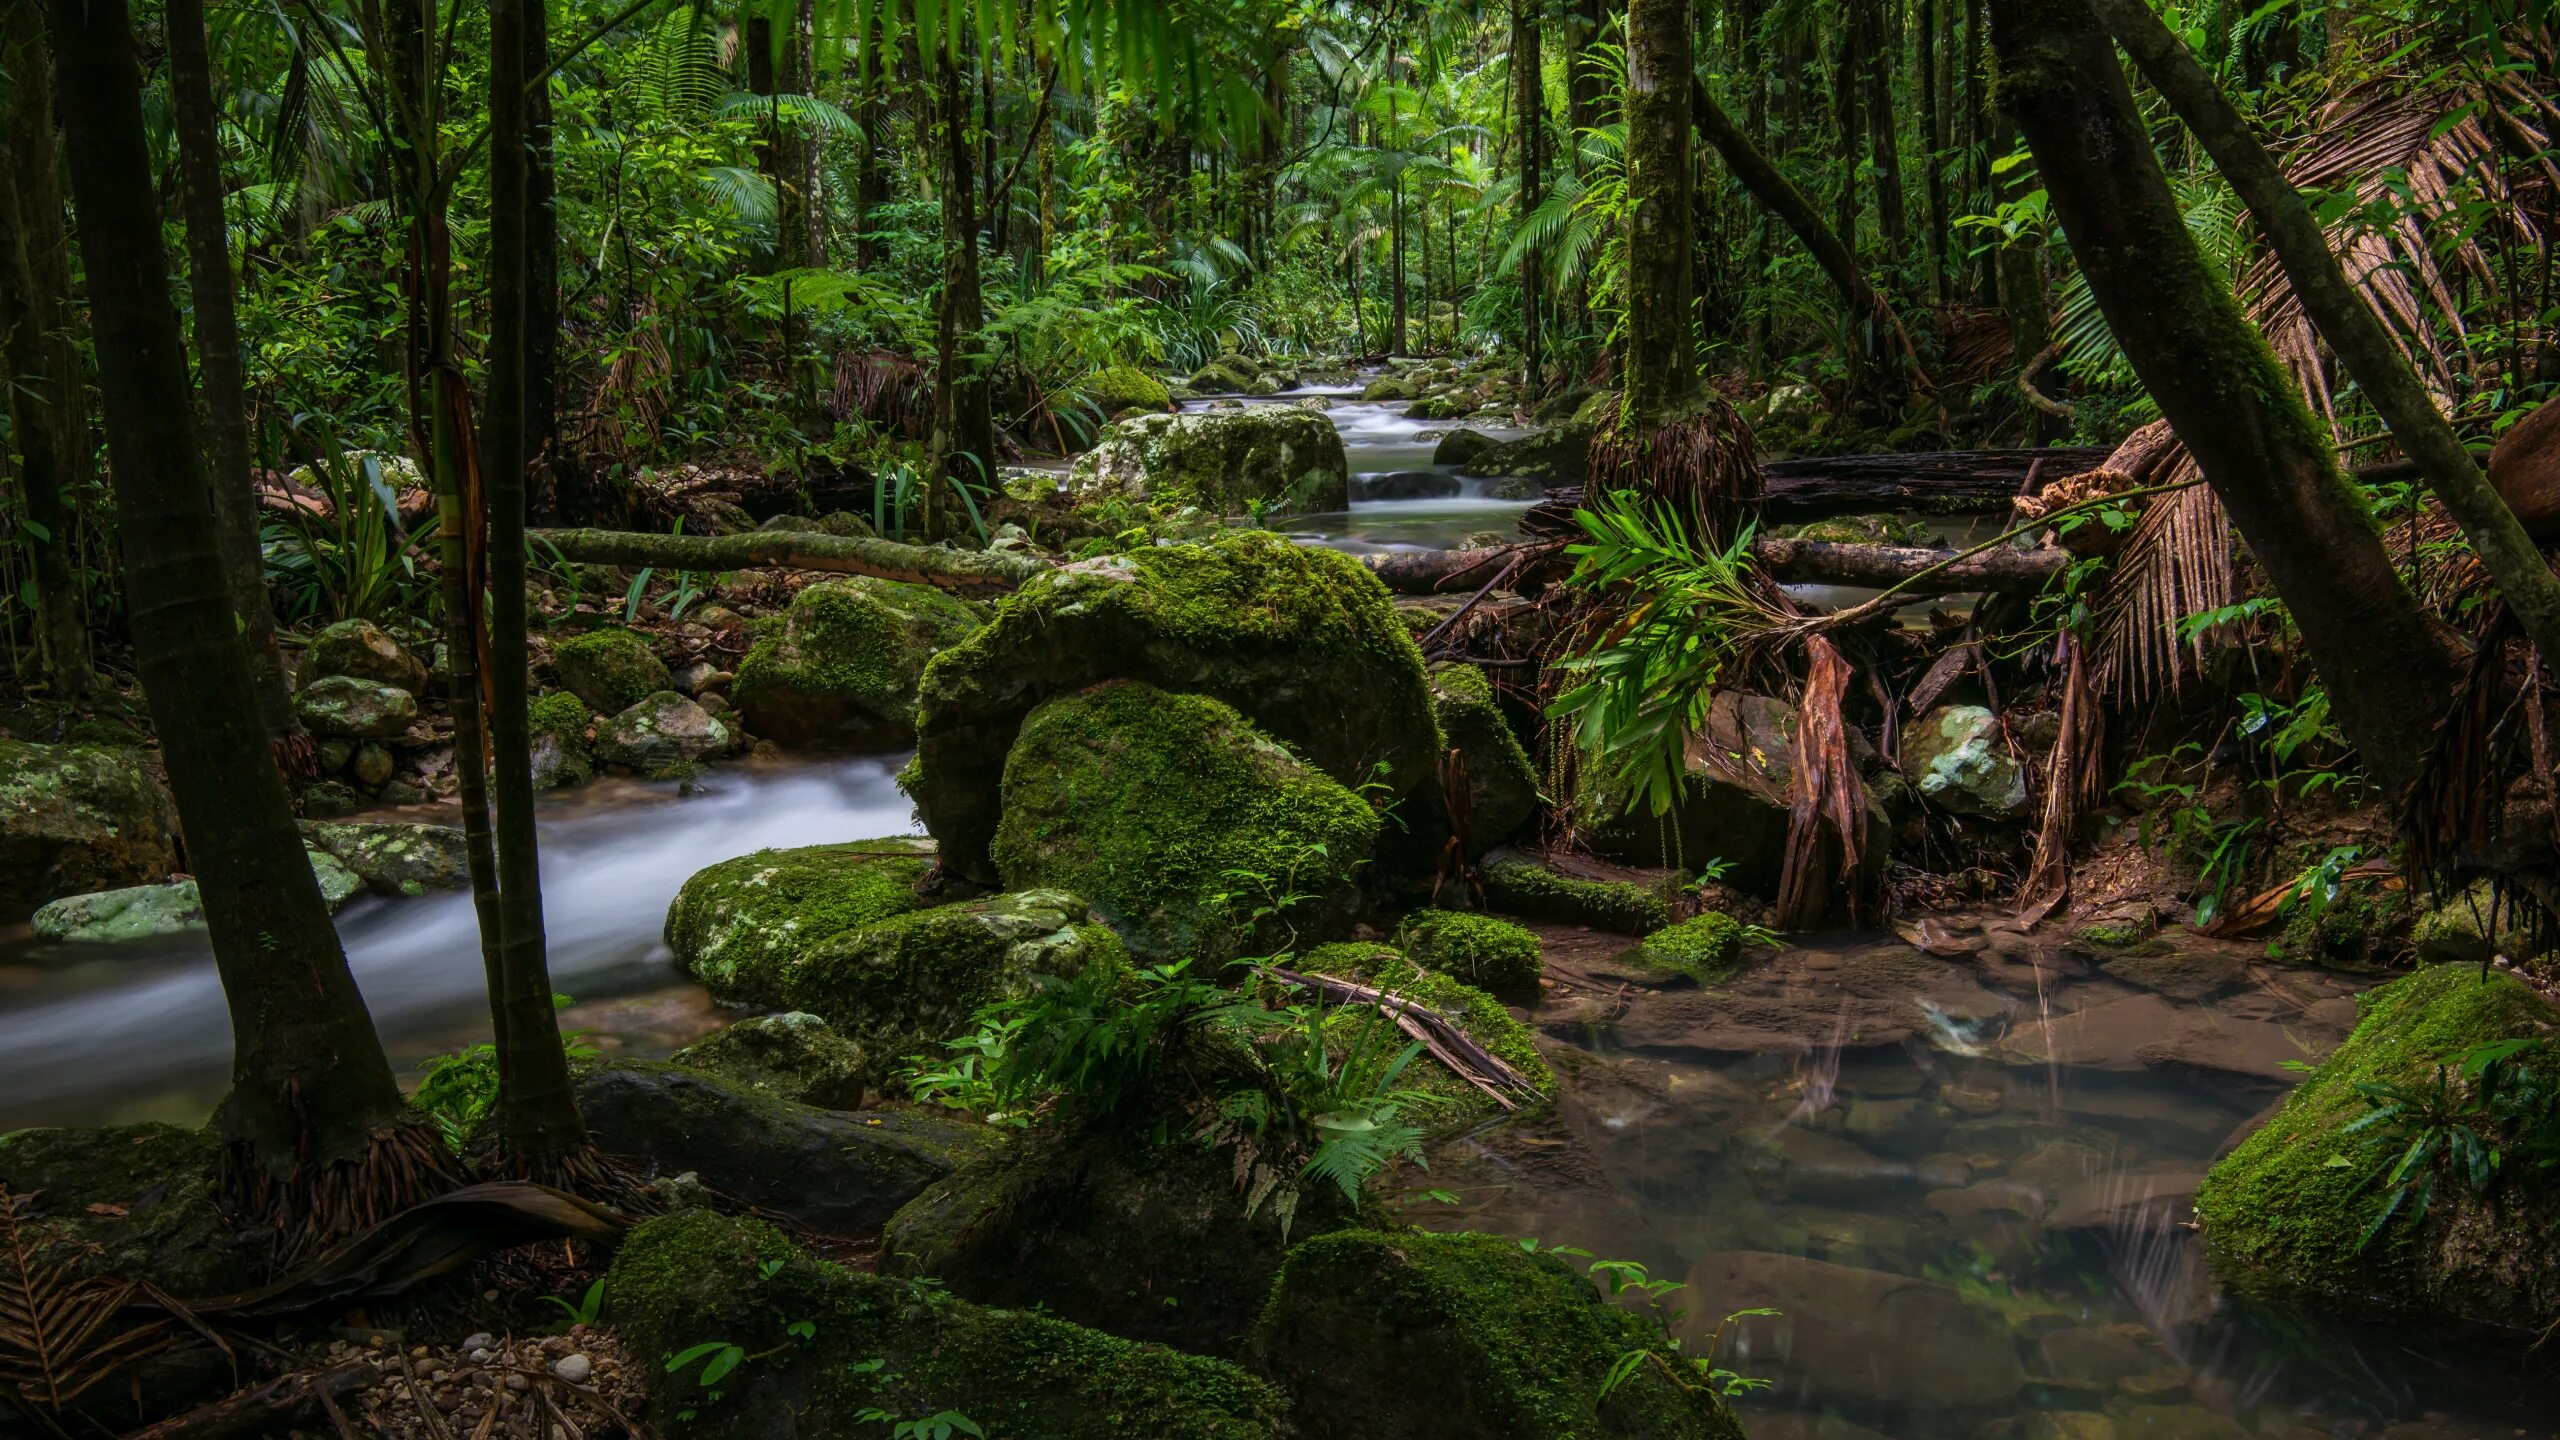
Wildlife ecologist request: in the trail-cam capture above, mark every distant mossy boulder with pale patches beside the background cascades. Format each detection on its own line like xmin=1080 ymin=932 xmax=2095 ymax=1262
xmin=1068 ymin=405 xmax=1352 ymax=515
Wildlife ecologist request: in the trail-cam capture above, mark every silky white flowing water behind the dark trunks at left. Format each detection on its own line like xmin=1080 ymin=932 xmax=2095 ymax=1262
xmin=0 ymin=756 xmax=916 ymax=1133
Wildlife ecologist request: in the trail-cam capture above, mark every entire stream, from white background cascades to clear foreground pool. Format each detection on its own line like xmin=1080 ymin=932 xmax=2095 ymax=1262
xmin=0 ymin=400 xmax=2560 ymax=1440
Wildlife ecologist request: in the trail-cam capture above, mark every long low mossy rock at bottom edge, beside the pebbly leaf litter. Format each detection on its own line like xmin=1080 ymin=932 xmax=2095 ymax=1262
xmin=604 ymin=1209 xmax=1288 ymax=1440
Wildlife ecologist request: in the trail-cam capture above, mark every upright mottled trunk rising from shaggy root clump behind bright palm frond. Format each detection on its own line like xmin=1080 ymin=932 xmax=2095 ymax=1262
xmin=1623 ymin=0 xmax=1700 ymax=422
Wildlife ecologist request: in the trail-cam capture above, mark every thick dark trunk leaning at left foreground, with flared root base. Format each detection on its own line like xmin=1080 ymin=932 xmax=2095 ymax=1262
xmin=51 ymin=0 xmax=443 ymax=1235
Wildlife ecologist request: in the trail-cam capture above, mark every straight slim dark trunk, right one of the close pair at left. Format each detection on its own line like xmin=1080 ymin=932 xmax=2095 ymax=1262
xmin=484 ymin=0 xmax=586 ymax=1179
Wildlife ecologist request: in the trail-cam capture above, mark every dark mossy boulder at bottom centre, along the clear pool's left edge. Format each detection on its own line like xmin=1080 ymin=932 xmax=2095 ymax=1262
xmin=1254 ymin=1230 xmax=1743 ymax=1440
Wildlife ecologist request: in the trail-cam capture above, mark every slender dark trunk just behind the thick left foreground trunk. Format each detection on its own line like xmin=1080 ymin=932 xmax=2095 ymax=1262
xmin=169 ymin=0 xmax=310 ymax=758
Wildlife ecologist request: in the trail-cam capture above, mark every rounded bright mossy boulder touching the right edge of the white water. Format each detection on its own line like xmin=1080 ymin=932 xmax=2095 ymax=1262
xmin=666 ymin=835 xmax=934 ymax=1004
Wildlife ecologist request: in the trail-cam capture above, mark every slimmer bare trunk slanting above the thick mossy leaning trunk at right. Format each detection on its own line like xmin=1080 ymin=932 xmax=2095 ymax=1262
xmin=2094 ymin=0 xmax=2560 ymax=661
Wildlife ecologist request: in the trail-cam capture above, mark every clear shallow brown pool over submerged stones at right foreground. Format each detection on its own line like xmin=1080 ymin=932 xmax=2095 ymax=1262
xmin=1423 ymin=930 xmax=2560 ymax=1440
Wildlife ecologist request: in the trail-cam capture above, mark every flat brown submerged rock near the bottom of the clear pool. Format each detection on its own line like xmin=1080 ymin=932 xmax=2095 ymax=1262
xmin=1687 ymin=1250 xmax=2025 ymax=1412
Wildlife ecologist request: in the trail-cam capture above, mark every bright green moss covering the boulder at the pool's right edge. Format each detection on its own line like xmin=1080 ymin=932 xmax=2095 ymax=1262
xmin=2196 ymin=966 xmax=2555 ymax=1302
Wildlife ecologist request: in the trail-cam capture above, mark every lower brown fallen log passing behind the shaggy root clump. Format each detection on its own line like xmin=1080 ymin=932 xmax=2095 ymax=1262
xmin=1362 ymin=536 xmax=2071 ymax=597
